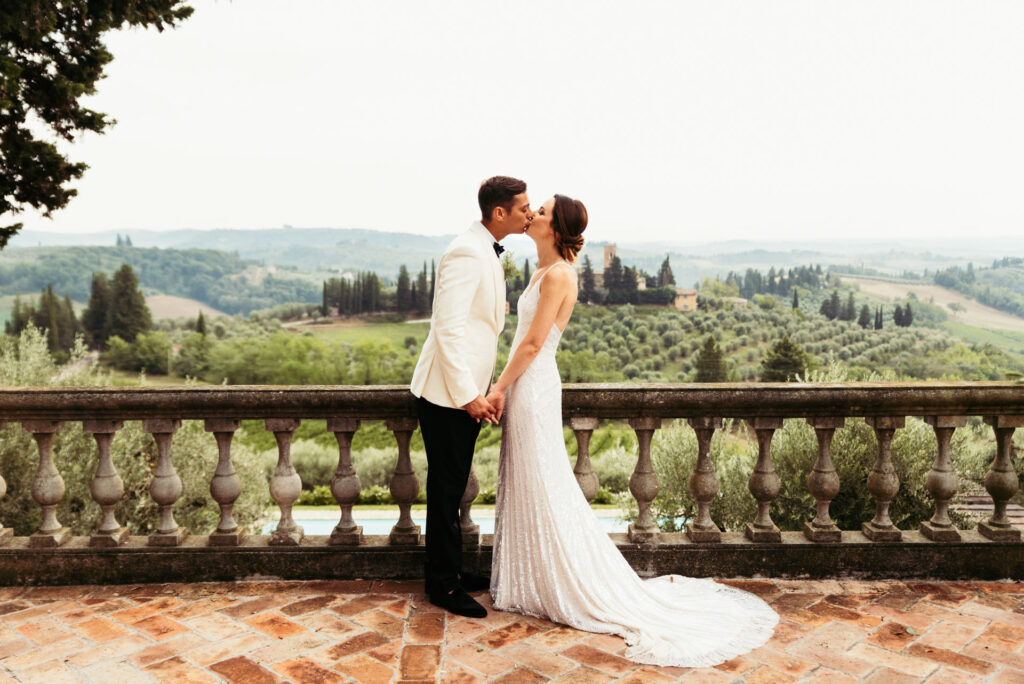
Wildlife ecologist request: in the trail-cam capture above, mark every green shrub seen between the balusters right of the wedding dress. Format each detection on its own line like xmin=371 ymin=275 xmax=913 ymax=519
xmin=621 ymin=411 xmax=990 ymax=531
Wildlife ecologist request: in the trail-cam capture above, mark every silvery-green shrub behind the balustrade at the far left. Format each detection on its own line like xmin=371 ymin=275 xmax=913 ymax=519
xmin=0 ymin=329 xmax=269 ymax=536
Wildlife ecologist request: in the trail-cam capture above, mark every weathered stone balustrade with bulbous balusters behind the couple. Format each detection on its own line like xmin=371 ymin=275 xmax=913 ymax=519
xmin=0 ymin=383 xmax=1024 ymax=583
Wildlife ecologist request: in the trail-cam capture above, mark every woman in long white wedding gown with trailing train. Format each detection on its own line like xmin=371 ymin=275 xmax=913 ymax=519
xmin=487 ymin=195 xmax=778 ymax=668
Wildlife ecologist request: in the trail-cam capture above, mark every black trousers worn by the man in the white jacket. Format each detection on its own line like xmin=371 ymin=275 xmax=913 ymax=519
xmin=416 ymin=397 xmax=480 ymax=593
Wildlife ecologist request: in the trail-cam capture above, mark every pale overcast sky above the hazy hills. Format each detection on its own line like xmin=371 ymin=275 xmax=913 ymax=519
xmin=16 ymin=0 xmax=1024 ymax=242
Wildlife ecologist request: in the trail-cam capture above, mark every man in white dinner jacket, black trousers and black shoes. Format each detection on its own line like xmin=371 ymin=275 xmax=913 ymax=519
xmin=410 ymin=176 xmax=534 ymax=617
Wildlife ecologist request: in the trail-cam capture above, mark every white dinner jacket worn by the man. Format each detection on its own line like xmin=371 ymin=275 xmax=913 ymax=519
xmin=410 ymin=221 xmax=505 ymax=409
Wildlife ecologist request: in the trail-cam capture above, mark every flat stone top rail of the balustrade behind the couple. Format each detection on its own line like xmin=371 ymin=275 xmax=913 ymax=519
xmin=0 ymin=382 xmax=1024 ymax=421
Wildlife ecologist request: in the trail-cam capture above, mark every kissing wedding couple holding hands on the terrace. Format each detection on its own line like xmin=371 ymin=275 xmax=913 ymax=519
xmin=411 ymin=176 xmax=778 ymax=668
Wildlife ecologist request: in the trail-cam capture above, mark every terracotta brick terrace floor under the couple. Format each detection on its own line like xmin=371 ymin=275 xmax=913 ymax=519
xmin=0 ymin=581 xmax=1024 ymax=684
